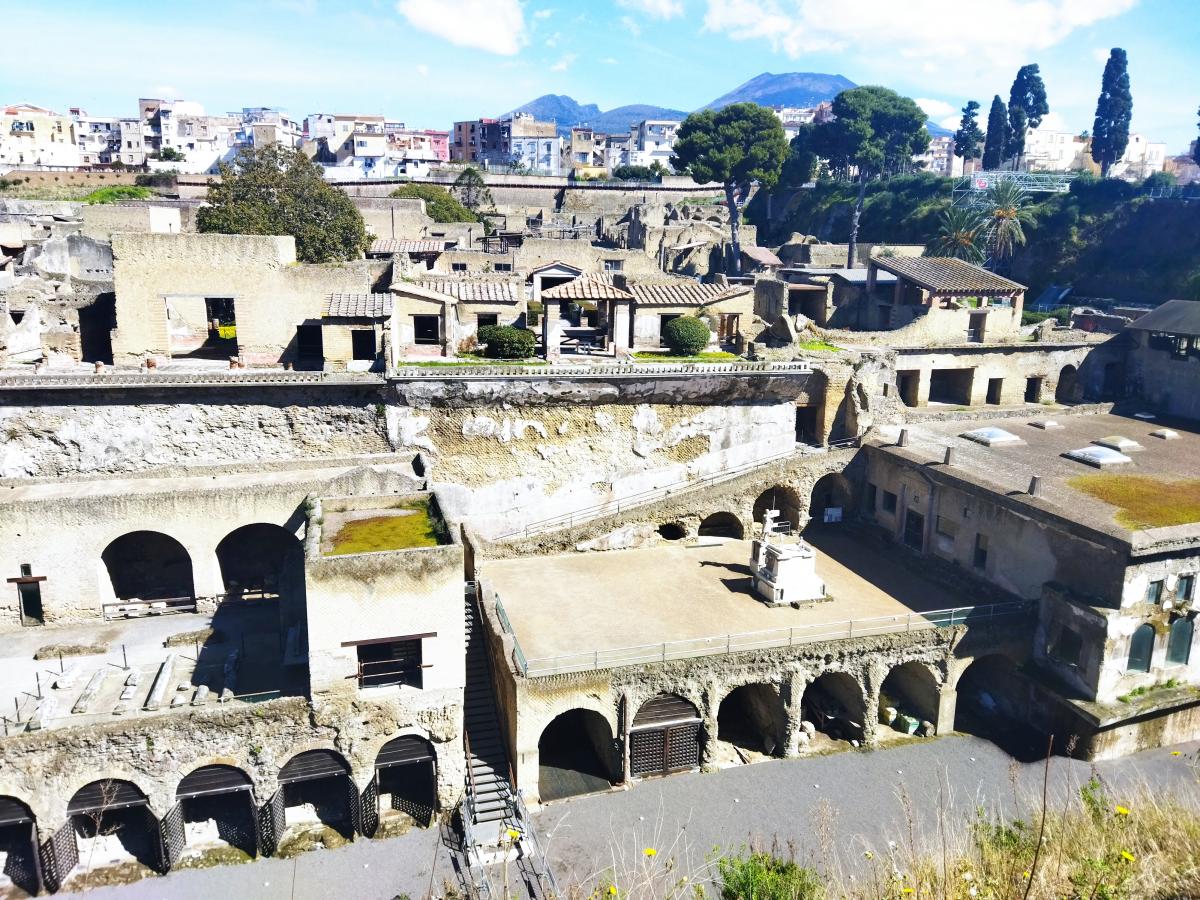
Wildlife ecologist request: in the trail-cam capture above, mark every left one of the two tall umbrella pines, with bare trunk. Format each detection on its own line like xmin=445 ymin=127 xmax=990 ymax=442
xmin=671 ymin=103 xmax=787 ymax=274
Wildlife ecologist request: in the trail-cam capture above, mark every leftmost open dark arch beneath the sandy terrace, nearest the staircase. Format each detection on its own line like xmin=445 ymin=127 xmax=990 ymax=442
xmin=538 ymin=709 xmax=619 ymax=802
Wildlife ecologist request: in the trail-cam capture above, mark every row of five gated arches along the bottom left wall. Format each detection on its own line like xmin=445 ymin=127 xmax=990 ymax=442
xmin=0 ymin=734 xmax=438 ymax=894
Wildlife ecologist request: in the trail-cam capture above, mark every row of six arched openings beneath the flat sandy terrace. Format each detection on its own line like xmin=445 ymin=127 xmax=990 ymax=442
xmin=538 ymin=654 xmax=1022 ymax=802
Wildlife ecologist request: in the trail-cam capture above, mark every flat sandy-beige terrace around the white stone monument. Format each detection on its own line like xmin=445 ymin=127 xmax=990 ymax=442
xmin=482 ymin=529 xmax=998 ymax=676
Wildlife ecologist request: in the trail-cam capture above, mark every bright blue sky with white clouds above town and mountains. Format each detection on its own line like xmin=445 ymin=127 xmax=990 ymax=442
xmin=0 ymin=0 xmax=1200 ymax=152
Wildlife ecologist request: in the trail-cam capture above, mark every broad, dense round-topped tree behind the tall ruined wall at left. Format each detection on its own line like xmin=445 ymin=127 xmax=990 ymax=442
xmin=196 ymin=144 xmax=367 ymax=263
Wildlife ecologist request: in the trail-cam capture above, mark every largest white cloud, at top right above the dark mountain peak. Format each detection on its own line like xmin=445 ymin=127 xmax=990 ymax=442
xmin=704 ymin=0 xmax=1139 ymax=67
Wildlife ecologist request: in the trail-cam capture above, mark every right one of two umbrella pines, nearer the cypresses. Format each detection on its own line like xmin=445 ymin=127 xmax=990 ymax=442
xmin=814 ymin=86 xmax=929 ymax=268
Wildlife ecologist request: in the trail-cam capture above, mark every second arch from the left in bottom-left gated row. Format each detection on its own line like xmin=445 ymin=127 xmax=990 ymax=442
xmin=62 ymin=779 xmax=166 ymax=875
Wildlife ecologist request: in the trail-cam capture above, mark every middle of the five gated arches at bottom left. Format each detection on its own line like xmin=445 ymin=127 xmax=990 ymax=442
xmin=175 ymin=766 xmax=258 ymax=857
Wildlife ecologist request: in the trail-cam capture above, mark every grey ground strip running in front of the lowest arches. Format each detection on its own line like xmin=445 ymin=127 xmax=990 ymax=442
xmin=70 ymin=736 xmax=1200 ymax=900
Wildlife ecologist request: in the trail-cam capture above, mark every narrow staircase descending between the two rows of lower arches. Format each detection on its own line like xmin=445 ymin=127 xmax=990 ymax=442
xmin=443 ymin=583 xmax=558 ymax=900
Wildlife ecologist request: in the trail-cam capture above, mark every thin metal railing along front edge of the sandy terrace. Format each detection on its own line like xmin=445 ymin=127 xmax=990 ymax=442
xmin=522 ymin=600 xmax=1034 ymax=678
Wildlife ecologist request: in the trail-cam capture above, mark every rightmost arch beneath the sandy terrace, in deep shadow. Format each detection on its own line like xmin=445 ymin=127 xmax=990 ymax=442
xmin=954 ymin=653 xmax=1046 ymax=762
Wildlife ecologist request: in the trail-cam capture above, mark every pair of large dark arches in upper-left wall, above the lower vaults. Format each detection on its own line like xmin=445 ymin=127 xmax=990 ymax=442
xmin=101 ymin=522 xmax=304 ymax=601
